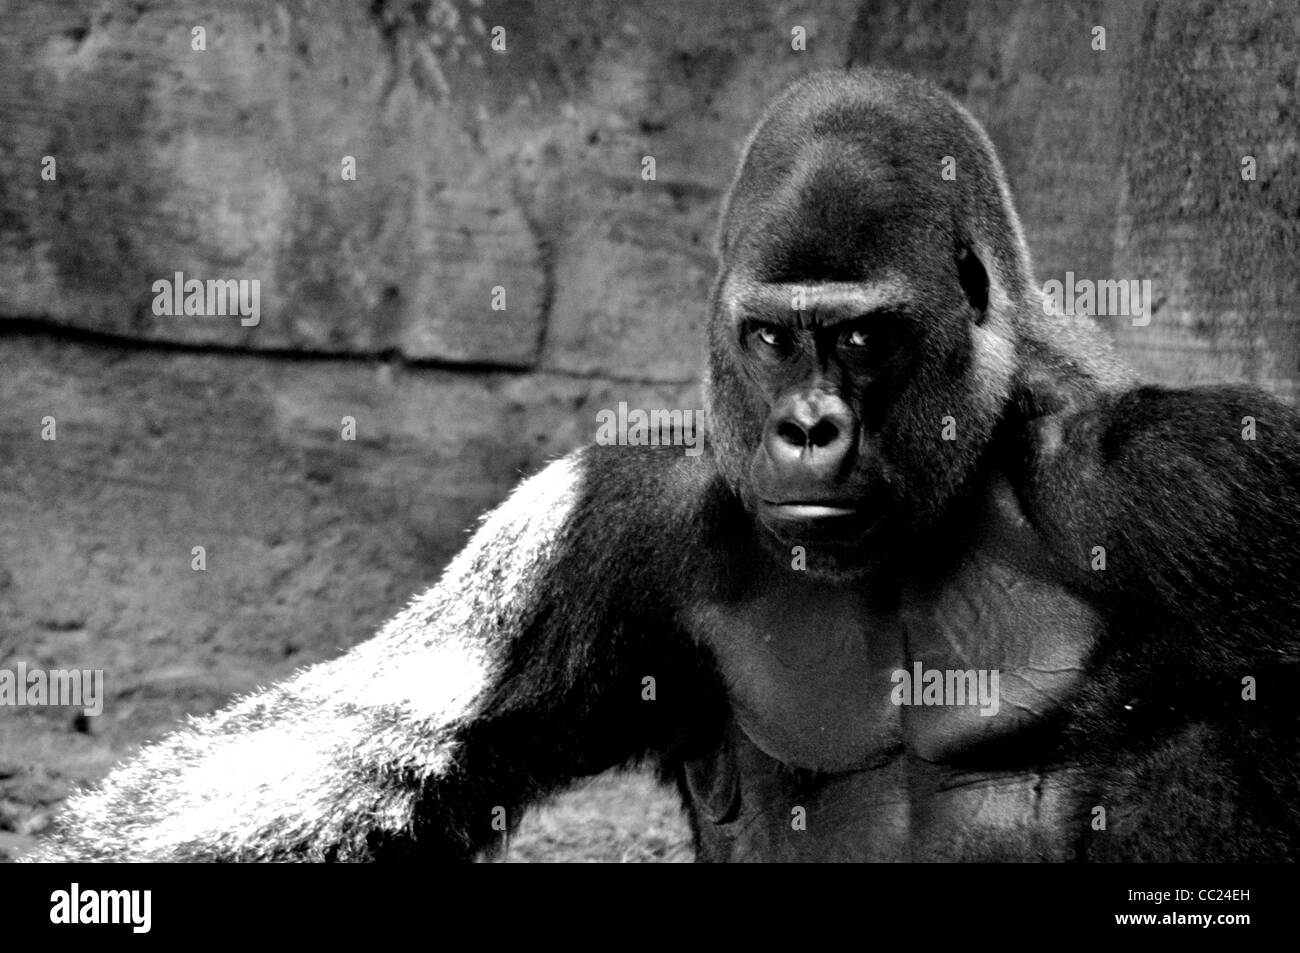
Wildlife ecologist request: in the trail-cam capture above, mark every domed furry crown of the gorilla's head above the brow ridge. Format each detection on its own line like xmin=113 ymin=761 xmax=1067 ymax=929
xmin=719 ymin=70 xmax=1022 ymax=291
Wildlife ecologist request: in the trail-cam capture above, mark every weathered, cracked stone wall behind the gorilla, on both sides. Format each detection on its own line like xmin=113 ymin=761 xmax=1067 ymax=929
xmin=0 ymin=0 xmax=1300 ymax=849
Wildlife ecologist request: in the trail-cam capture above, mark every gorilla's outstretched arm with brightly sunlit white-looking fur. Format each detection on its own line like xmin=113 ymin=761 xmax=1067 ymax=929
xmin=25 ymin=447 xmax=701 ymax=861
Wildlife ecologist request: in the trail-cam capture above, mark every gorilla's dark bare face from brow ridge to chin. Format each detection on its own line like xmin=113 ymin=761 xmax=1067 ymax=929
xmin=724 ymin=249 xmax=992 ymax=571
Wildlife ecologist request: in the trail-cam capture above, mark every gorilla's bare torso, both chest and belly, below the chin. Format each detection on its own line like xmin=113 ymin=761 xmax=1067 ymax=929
xmin=686 ymin=556 xmax=1100 ymax=859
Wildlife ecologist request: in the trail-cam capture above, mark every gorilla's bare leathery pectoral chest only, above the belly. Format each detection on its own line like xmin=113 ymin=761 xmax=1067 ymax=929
xmin=696 ymin=555 xmax=1100 ymax=772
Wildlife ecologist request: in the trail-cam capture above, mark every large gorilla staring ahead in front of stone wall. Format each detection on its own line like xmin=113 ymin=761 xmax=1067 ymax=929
xmin=27 ymin=70 xmax=1300 ymax=861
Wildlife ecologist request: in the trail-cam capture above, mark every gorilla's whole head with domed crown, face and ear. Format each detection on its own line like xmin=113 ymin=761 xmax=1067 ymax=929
xmin=709 ymin=72 xmax=1040 ymax=575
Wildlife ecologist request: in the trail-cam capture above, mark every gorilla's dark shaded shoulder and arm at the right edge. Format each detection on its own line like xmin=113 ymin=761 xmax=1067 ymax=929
xmin=1021 ymin=386 xmax=1300 ymax=862
